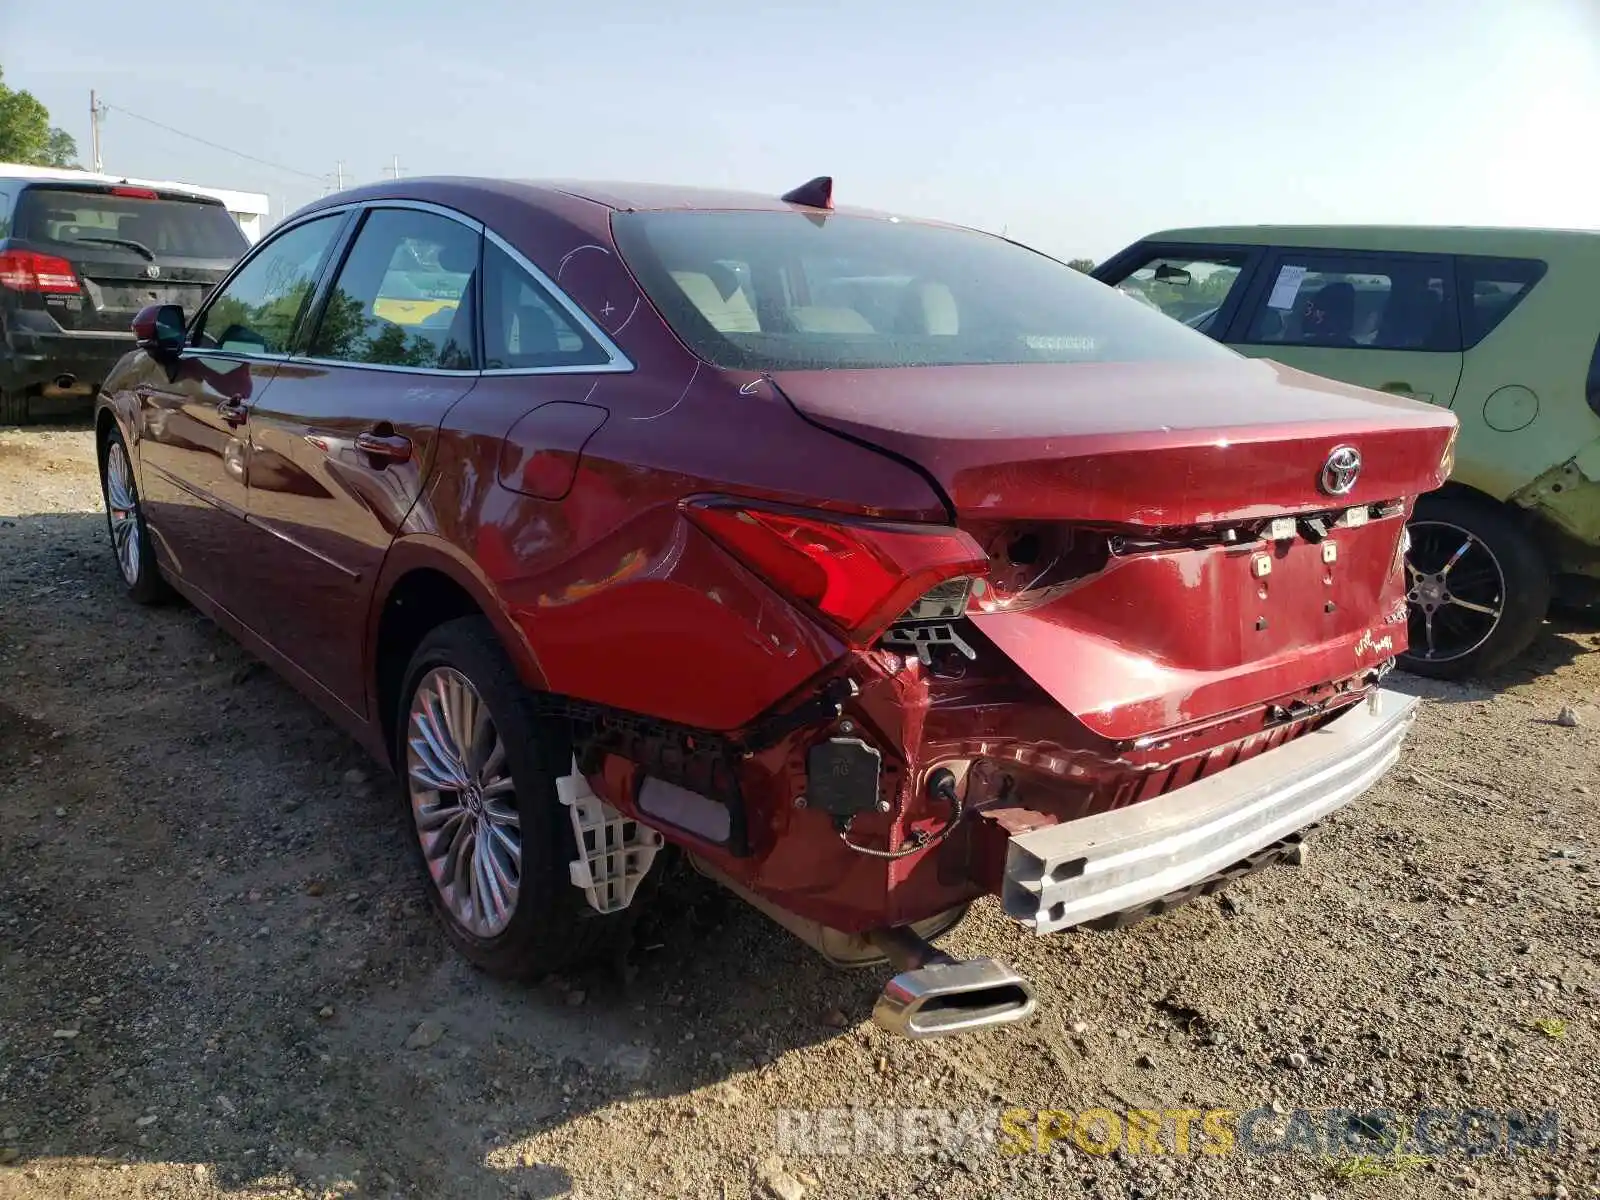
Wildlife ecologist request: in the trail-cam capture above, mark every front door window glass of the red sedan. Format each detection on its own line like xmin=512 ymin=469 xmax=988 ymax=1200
xmin=194 ymin=213 xmax=344 ymax=354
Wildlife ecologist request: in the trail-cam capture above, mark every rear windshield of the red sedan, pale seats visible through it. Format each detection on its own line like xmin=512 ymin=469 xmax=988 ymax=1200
xmin=613 ymin=211 xmax=1234 ymax=371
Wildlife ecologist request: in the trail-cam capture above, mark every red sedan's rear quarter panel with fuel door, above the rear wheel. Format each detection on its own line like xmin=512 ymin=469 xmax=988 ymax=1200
xmin=374 ymin=191 xmax=944 ymax=730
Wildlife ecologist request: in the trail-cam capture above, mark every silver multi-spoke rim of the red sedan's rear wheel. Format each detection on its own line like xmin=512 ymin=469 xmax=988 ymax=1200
xmin=405 ymin=667 xmax=522 ymax=938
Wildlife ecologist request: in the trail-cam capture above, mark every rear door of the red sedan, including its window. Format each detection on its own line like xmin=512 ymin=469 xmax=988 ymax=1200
xmin=248 ymin=202 xmax=483 ymax=714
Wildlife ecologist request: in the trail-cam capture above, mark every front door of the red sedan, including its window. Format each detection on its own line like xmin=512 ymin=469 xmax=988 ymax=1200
xmin=134 ymin=214 xmax=347 ymax=611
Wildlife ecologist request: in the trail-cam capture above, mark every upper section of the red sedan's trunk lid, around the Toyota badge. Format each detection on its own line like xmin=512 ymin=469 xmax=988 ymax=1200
xmin=773 ymin=358 xmax=1454 ymax=526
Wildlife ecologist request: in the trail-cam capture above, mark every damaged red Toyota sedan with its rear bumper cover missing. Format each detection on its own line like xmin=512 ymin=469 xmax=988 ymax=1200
xmin=98 ymin=179 xmax=1454 ymax=1037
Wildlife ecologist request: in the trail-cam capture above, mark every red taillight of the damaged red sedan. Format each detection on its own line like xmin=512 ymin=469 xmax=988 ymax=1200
xmin=688 ymin=502 xmax=989 ymax=646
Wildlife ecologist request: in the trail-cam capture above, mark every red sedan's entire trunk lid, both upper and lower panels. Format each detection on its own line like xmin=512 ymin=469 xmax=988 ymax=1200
xmin=774 ymin=360 xmax=1454 ymax=739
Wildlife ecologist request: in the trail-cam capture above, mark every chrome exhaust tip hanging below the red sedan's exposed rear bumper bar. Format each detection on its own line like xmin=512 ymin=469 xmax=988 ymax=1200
xmin=867 ymin=928 xmax=1037 ymax=1038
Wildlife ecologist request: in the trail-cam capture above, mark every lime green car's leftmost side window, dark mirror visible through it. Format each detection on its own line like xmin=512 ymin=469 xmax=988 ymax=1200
xmin=1093 ymin=242 xmax=1266 ymax=336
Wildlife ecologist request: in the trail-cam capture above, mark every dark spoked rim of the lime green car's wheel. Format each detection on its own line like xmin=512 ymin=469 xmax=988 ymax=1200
xmin=1405 ymin=520 xmax=1506 ymax=662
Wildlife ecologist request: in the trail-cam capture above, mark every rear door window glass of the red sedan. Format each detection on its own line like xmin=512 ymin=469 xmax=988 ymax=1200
xmin=310 ymin=208 xmax=482 ymax=371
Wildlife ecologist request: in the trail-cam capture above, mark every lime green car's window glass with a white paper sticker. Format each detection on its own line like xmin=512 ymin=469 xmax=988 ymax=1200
xmin=1242 ymin=251 xmax=1456 ymax=350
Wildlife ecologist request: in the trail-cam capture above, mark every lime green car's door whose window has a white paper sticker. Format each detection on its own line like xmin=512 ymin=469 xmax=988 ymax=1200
xmin=1224 ymin=248 xmax=1461 ymax=408
